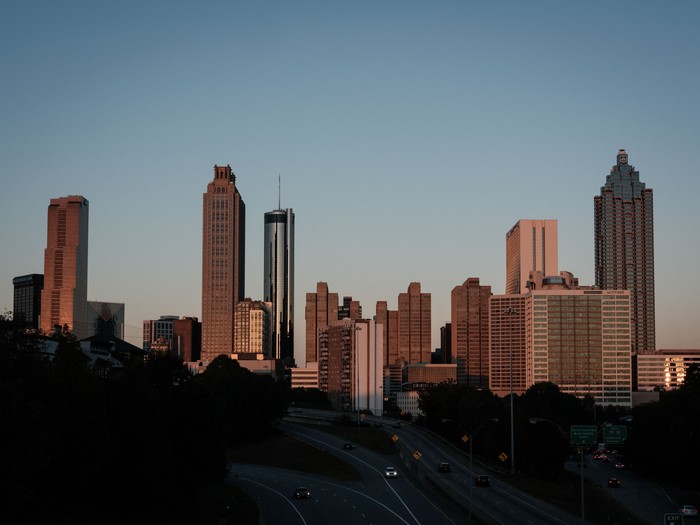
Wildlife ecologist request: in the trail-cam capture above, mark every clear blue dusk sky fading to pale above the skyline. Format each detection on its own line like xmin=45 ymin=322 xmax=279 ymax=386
xmin=0 ymin=0 xmax=700 ymax=351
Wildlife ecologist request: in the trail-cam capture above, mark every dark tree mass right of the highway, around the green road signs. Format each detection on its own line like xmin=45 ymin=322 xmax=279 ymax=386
xmin=419 ymin=365 xmax=700 ymax=488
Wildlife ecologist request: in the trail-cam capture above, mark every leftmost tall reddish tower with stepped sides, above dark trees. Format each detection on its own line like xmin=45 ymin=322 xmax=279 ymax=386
xmin=41 ymin=195 xmax=89 ymax=339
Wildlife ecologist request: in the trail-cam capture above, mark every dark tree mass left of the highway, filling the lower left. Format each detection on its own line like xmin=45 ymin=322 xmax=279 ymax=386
xmin=0 ymin=323 xmax=287 ymax=523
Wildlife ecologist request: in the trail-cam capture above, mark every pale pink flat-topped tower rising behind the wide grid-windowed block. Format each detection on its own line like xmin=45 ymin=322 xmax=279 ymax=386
xmin=506 ymin=219 xmax=559 ymax=295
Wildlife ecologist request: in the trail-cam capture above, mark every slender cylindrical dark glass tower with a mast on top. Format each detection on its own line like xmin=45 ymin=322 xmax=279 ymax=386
xmin=263 ymin=208 xmax=294 ymax=365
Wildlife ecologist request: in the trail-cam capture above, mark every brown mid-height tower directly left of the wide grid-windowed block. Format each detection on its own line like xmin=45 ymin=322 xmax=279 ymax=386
xmin=451 ymin=277 xmax=491 ymax=388
